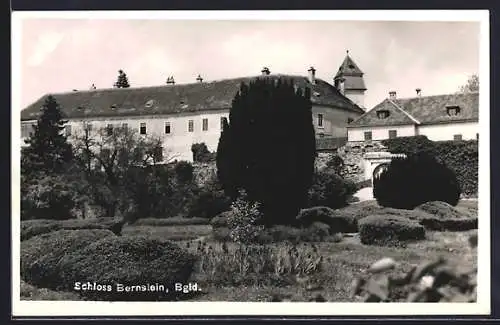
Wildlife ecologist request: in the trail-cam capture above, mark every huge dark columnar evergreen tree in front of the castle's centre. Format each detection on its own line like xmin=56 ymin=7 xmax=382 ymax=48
xmin=217 ymin=77 xmax=316 ymax=224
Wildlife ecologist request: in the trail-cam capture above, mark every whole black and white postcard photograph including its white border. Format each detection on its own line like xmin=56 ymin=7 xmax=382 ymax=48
xmin=11 ymin=10 xmax=491 ymax=316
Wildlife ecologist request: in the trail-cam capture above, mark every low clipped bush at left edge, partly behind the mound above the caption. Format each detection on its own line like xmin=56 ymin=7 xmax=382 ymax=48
xmin=20 ymin=229 xmax=118 ymax=289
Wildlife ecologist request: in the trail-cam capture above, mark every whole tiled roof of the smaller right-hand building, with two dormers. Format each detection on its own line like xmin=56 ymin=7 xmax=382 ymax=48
xmin=348 ymin=92 xmax=479 ymax=128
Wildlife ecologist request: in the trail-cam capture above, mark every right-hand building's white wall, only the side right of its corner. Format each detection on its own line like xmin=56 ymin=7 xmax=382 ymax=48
xmin=418 ymin=122 xmax=479 ymax=141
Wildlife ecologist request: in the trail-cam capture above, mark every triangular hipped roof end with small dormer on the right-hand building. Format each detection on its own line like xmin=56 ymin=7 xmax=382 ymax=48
xmin=348 ymin=99 xmax=416 ymax=128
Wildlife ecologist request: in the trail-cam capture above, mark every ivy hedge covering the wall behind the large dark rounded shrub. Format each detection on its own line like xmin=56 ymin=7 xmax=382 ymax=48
xmin=382 ymin=135 xmax=479 ymax=196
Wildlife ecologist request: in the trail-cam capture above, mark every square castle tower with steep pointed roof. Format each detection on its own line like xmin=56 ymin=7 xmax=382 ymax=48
xmin=333 ymin=51 xmax=366 ymax=109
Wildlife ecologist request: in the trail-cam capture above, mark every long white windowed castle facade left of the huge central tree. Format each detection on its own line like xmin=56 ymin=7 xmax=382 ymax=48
xmin=22 ymin=110 xmax=229 ymax=161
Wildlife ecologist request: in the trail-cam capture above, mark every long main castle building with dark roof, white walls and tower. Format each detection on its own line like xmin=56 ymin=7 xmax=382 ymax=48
xmin=21 ymin=56 xmax=364 ymax=161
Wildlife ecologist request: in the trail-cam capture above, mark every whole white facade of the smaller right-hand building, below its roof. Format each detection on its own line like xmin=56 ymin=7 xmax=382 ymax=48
xmin=347 ymin=122 xmax=479 ymax=142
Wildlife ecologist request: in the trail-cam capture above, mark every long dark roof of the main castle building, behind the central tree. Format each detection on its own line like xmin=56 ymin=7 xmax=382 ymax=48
xmin=21 ymin=74 xmax=364 ymax=120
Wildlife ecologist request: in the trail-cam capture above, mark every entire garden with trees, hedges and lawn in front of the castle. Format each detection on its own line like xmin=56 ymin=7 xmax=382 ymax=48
xmin=20 ymin=80 xmax=478 ymax=302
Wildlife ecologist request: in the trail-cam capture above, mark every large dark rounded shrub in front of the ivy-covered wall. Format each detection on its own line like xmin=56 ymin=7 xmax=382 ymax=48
xmin=373 ymin=153 xmax=460 ymax=209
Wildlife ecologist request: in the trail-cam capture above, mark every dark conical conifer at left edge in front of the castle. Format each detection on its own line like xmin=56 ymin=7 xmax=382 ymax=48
xmin=21 ymin=96 xmax=73 ymax=176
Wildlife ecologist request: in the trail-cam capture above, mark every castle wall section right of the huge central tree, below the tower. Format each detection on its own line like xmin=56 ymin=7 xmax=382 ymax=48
xmin=312 ymin=105 xmax=361 ymax=137
